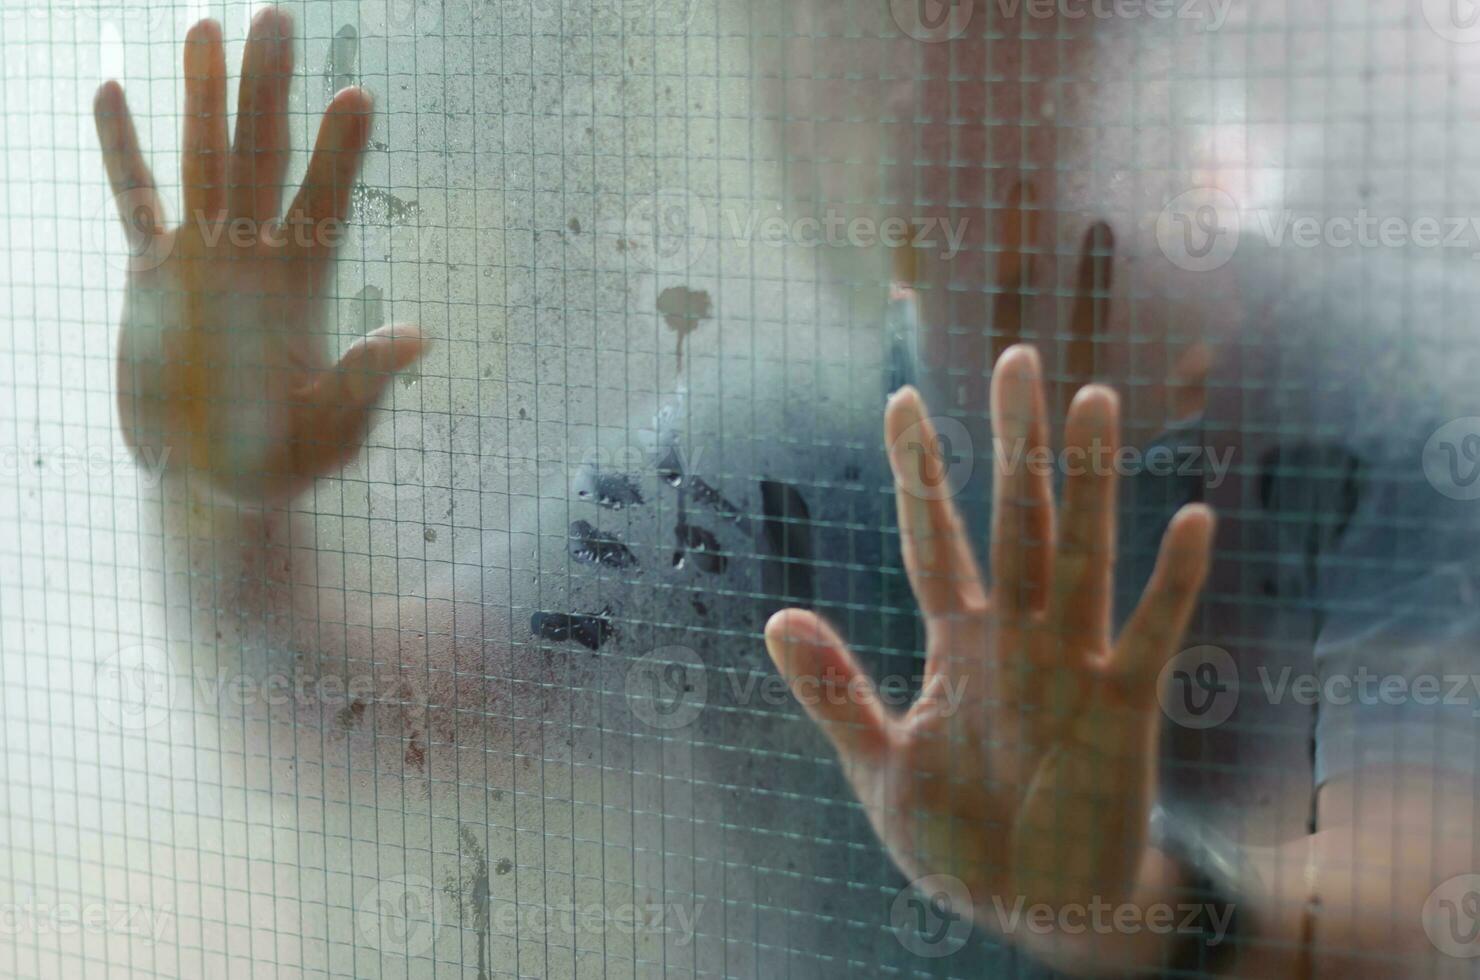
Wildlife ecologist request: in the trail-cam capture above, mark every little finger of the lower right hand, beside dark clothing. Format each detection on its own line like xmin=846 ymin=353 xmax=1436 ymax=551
xmin=1109 ymin=503 xmax=1217 ymax=700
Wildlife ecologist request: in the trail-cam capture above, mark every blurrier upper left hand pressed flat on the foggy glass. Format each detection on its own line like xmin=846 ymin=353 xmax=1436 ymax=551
xmin=93 ymin=7 xmax=423 ymax=503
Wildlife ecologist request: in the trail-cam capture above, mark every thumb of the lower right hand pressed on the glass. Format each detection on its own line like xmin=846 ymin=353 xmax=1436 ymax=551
xmin=765 ymin=610 xmax=894 ymax=764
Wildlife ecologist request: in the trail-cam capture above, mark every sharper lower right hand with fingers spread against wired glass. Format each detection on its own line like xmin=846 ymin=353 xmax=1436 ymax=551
xmin=765 ymin=346 xmax=1214 ymax=955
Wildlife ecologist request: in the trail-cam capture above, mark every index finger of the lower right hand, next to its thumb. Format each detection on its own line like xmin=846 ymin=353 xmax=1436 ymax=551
xmin=884 ymin=388 xmax=987 ymax=617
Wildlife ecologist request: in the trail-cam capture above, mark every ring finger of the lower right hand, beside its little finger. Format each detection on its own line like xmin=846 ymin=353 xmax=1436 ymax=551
xmin=1049 ymin=385 xmax=1120 ymax=662
